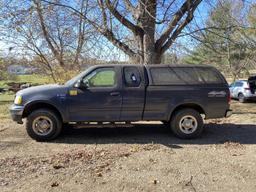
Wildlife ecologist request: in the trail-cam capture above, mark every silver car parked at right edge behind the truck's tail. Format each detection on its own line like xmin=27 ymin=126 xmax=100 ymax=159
xmin=229 ymin=77 xmax=256 ymax=103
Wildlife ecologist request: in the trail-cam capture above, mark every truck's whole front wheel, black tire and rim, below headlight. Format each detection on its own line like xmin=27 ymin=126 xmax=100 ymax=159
xmin=26 ymin=109 xmax=62 ymax=141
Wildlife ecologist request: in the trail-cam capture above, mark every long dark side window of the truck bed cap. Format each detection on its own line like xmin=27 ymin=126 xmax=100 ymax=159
xmin=150 ymin=67 xmax=203 ymax=85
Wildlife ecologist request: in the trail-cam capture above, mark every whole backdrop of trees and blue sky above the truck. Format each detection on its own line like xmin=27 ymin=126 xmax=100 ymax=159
xmin=0 ymin=0 xmax=256 ymax=81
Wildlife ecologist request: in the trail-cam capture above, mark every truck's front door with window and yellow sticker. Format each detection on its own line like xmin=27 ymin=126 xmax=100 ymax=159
xmin=68 ymin=66 xmax=122 ymax=121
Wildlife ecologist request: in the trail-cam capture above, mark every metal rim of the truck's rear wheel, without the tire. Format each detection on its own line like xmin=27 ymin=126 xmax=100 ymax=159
xmin=179 ymin=115 xmax=198 ymax=134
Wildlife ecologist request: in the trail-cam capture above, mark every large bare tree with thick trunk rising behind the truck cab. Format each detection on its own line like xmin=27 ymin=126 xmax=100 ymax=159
xmin=42 ymin=0 xmax=201 ymax=64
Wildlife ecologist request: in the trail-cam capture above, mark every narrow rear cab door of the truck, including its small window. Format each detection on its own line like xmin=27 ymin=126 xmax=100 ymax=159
xmin=120 ymin=66 xmax=146 ymax=121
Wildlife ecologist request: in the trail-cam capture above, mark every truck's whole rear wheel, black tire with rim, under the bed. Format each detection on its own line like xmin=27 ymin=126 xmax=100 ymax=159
xmin=170 ymin=108 xmax=204 ymax=139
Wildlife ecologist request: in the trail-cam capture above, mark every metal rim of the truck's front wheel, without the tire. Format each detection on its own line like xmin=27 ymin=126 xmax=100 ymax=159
xmin=32 ymin=116 xmax=53 ymax=136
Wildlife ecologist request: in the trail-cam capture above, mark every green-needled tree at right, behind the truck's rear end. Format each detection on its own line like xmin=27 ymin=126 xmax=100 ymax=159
xmin=185 ymin=0 xmax=256 ymax=80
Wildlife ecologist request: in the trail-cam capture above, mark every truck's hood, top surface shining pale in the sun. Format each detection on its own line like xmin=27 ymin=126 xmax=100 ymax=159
xmin=16 ymin=84 xmax=65 ymax=95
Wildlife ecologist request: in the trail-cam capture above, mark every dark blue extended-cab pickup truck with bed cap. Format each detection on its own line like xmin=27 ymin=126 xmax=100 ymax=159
xmin=10 ymin=64 xmax=232 ymax=141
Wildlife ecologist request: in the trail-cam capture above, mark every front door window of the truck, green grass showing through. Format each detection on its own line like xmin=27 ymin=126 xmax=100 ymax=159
xmin=82 ymin=67 xmax=116 ymax=87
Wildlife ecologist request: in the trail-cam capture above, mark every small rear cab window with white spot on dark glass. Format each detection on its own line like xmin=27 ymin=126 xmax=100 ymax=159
xmin=124 ymin=67 xmax=141 ymax=87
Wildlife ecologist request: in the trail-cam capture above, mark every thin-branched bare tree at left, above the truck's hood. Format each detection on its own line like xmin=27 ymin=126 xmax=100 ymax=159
xmin=0 ymin=0 xmax=98 ymax=80
